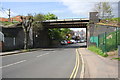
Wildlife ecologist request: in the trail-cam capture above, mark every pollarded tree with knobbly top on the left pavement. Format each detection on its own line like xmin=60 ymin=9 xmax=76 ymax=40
xmin=21 ymin=14 xmax=33 ymax=49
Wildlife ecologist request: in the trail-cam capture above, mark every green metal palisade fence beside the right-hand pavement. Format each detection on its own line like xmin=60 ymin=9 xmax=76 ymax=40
xmin=90 ymin=27 xmax=120 ymax=53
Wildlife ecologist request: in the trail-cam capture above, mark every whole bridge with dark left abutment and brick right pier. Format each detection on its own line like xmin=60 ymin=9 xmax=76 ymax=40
xmin=34 ymin=12 xmax=99 ymax=47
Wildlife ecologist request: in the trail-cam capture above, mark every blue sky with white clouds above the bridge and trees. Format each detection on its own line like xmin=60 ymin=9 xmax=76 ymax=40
xmin=0 ymin=0 xmax=118 ymax=30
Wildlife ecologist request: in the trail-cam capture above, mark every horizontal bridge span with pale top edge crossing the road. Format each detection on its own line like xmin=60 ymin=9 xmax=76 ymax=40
xmin=42 ymin=19 xmax=89 ymax=28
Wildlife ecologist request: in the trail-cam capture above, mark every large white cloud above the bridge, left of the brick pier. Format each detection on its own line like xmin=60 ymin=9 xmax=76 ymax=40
xmin=60 ymin=0 xmax=95 ymax=17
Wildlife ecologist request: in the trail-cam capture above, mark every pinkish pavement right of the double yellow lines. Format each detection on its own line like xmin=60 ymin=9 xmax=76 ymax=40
xmin=79 ymin=48 xmax=118 ymax=78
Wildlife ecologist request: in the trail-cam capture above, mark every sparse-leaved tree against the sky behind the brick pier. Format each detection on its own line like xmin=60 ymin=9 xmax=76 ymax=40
xmin=94 ymin=2 xmax=113 ymax=19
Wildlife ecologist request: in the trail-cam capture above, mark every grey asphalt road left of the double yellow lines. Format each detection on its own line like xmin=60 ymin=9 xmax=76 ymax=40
xmin=0 ymin=43 xmax=84 ymax=78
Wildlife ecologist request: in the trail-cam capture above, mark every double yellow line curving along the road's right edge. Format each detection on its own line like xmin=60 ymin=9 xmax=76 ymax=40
xmin=69 ymin=49 xmax=80 ymax=80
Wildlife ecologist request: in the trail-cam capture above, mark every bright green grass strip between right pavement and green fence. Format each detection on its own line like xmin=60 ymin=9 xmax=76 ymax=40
xmin=88 ymin=46 xmax=108 ymax=57
